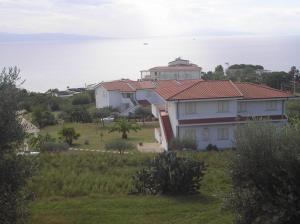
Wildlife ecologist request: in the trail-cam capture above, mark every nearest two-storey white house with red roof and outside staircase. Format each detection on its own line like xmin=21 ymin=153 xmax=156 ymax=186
xmin=152 ymin=80 xmax=293 ymax=150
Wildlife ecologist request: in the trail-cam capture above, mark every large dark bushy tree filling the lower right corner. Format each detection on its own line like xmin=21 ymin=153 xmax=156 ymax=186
xmin=229 ymin=123 xmax=300 ymax=224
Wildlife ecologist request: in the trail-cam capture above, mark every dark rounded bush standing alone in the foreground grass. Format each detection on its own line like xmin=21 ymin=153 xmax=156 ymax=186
xmin=133 ymin=152 xmax=205 ymax=195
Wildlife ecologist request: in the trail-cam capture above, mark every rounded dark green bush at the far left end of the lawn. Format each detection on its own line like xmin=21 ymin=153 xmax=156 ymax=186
xmin=32 ymin=108 xmax=57 ymax=128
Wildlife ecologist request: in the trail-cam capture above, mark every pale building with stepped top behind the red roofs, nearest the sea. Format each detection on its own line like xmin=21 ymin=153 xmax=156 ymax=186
xmin=141 ymin=58 xmax=202 ymax=80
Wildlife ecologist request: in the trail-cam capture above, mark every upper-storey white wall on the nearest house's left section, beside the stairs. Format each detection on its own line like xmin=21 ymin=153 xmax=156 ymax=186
xmin=178 ymin=100 xmax=237 ymax=120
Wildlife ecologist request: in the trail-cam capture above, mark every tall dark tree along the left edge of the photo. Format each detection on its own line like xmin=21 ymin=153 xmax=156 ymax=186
xmin=0 ymin=67 xmax=33 ymax=224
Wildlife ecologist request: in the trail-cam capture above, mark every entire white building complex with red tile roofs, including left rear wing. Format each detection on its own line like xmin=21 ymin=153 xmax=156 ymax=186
xmin=96 ymin=79 xmax=294 ymax=150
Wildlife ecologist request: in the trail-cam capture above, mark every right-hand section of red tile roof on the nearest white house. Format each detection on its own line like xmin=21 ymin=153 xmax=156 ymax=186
xmin=235 ymin=82 xmax=293 ymax=99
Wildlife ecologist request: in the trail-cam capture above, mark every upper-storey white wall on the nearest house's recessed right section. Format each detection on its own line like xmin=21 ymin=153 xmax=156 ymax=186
xmin=238 ymin=100 xmax=284 ymax=117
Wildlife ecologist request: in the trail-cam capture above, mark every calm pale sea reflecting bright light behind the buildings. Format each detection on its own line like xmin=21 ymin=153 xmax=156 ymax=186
xmin=0 ymin=37 xmax=300 ymax=91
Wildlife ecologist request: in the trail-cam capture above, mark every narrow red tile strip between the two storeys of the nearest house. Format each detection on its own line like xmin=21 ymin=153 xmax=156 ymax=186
xmin=178 ymin=115 xmax=287 ymax=125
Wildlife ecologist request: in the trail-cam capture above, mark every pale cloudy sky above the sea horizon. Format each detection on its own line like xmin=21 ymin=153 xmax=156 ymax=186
xmin=0 ymin=0 xmax=300 ymax=38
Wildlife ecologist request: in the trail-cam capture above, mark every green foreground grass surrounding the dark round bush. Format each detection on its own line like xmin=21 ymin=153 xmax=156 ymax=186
xmin=28 ymin=151 xmax=234 ymax=224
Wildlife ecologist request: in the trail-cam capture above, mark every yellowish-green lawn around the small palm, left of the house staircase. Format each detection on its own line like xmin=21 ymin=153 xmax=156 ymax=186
xmin=41 ymin=123 xmax=158 ymax=150
